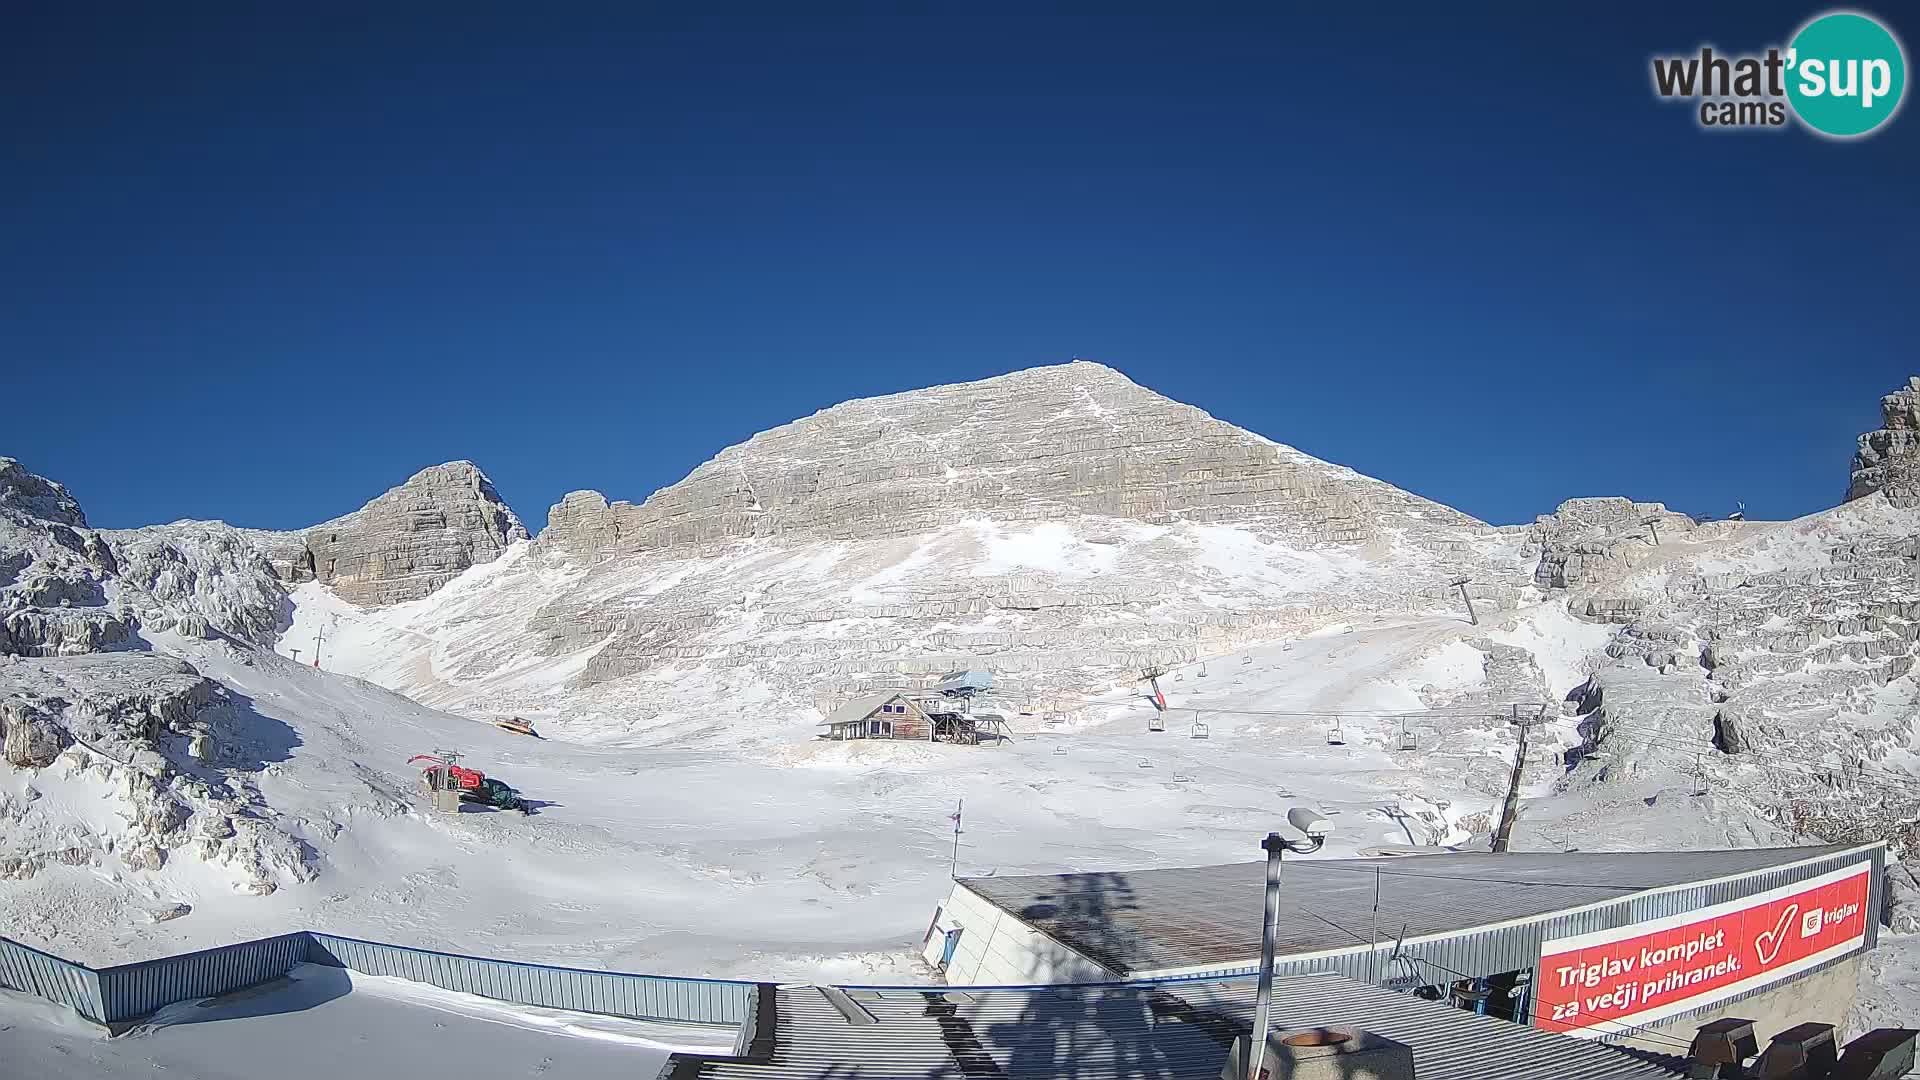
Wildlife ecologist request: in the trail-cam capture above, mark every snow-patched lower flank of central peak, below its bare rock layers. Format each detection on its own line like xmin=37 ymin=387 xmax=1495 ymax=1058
xmin=278 ymin=507 xmax=1519 ymax=746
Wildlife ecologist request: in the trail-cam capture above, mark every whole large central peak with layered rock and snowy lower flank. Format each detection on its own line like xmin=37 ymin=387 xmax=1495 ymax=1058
xmin=396 ymin=361 xmax=1530 ymax=718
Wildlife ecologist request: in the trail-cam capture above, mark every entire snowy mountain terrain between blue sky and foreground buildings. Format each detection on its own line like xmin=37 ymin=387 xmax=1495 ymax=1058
xmin=0 ymin=363 xmax=1920 ymax=978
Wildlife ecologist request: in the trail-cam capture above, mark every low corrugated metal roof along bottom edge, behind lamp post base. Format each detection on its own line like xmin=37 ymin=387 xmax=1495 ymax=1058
xmin=660 ymin=974 xmax=1682 ymax=1080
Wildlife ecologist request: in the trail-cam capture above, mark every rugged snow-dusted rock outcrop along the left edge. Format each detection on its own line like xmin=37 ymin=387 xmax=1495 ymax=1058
xmin=0 ymin=459 xmax=315 ymax=899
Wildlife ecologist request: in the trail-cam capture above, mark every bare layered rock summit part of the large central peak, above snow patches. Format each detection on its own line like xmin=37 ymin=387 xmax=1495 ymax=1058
xmin=540 ymin=361 xmax=1480 ymax=557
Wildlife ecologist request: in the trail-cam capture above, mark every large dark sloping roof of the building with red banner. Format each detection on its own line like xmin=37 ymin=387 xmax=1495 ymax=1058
xmin=960 ymin=844 xmax=1847 ymax=976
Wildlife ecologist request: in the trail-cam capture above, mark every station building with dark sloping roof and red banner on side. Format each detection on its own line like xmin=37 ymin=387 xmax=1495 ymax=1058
xmin=922 ymin=844 xmax=1885 ymax=1045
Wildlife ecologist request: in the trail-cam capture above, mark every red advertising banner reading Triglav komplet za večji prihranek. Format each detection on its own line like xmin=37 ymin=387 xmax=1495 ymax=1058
xmin=1534 ymin=863 xmax=1874 ymax=1038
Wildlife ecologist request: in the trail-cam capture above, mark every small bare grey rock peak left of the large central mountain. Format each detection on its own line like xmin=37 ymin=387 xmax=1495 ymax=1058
xmin=270 ymin=461 xmax=528 ymax=607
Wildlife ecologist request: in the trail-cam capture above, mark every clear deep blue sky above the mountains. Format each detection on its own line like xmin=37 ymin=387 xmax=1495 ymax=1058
xmin=0 ymin=2 xmax=1920 ymax=528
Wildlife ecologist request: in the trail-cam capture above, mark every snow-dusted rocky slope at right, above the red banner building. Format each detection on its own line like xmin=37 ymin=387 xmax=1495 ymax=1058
xmin=1567 ymin=486 xmax=1920 ymax=857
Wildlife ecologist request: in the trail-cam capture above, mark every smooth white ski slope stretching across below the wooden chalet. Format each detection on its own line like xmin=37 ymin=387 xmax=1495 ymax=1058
xmin=0 ymin=607 xmax=1582 ymax=980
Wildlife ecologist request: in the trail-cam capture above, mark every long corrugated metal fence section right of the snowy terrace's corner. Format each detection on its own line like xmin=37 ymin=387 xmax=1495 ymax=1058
xmin=307 ymin=934 xmax=755 ymax=1024
